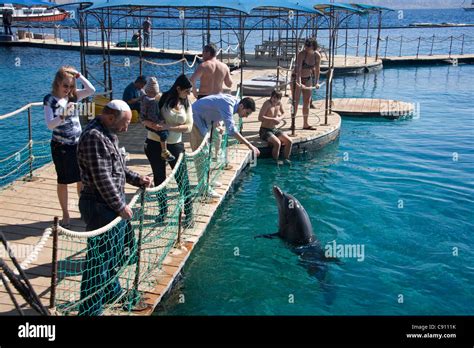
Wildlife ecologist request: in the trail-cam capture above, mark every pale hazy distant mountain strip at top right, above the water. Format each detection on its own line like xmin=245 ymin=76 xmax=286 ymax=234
xmin=335 ymin=0 xmax=464 ymax=10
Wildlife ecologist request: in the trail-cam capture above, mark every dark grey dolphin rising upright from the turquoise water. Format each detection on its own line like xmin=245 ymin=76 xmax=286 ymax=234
xmin=256 ymin=186 xmax=340 ymax=304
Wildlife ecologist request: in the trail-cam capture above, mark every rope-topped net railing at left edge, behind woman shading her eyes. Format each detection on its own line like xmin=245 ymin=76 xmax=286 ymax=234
xmin=0 ymin=103 xmax=51 ymax=190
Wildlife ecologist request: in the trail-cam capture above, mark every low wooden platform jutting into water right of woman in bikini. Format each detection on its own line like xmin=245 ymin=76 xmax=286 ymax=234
xmin=315 ymin=98 xmax=415 ymax=119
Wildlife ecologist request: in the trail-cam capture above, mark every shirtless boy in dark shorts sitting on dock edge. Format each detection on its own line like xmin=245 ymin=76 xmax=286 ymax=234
xmin=258 ymin=90 xmax=293 ymax=164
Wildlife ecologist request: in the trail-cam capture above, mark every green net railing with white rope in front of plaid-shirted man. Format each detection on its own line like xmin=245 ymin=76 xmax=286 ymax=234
xmin=51 ymin=132 xmax=236 ymax=315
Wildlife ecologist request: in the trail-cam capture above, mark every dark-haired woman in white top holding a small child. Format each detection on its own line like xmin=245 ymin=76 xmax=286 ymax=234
xmin=142 ymin=75 xmax=193 ymax=228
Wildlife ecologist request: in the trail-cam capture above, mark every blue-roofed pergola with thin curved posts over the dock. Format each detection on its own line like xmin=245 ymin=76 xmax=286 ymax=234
xmin=54 ymin=0 xmax=389 ymax=135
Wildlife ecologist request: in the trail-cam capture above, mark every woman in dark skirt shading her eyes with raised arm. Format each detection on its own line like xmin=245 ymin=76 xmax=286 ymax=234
xmin=43 ymin=66 xmax=95 ymax=228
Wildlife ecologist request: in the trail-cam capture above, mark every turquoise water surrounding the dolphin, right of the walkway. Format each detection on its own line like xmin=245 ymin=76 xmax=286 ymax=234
xmin=157 ymin=65 xmax=474 ymax=315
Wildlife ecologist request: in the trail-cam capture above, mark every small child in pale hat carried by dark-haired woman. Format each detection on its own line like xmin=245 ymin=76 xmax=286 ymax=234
xmin=140 ymin=77 xmax=176 ymax=162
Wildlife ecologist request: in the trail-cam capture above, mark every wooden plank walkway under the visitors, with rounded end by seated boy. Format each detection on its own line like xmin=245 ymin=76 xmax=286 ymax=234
xmin=0 ymin=88 xmax=341 ymax=315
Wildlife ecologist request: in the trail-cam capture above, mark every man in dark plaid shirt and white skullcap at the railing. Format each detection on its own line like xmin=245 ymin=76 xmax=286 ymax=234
xmin=77 ymin=100 xmax=152 ymax=315
